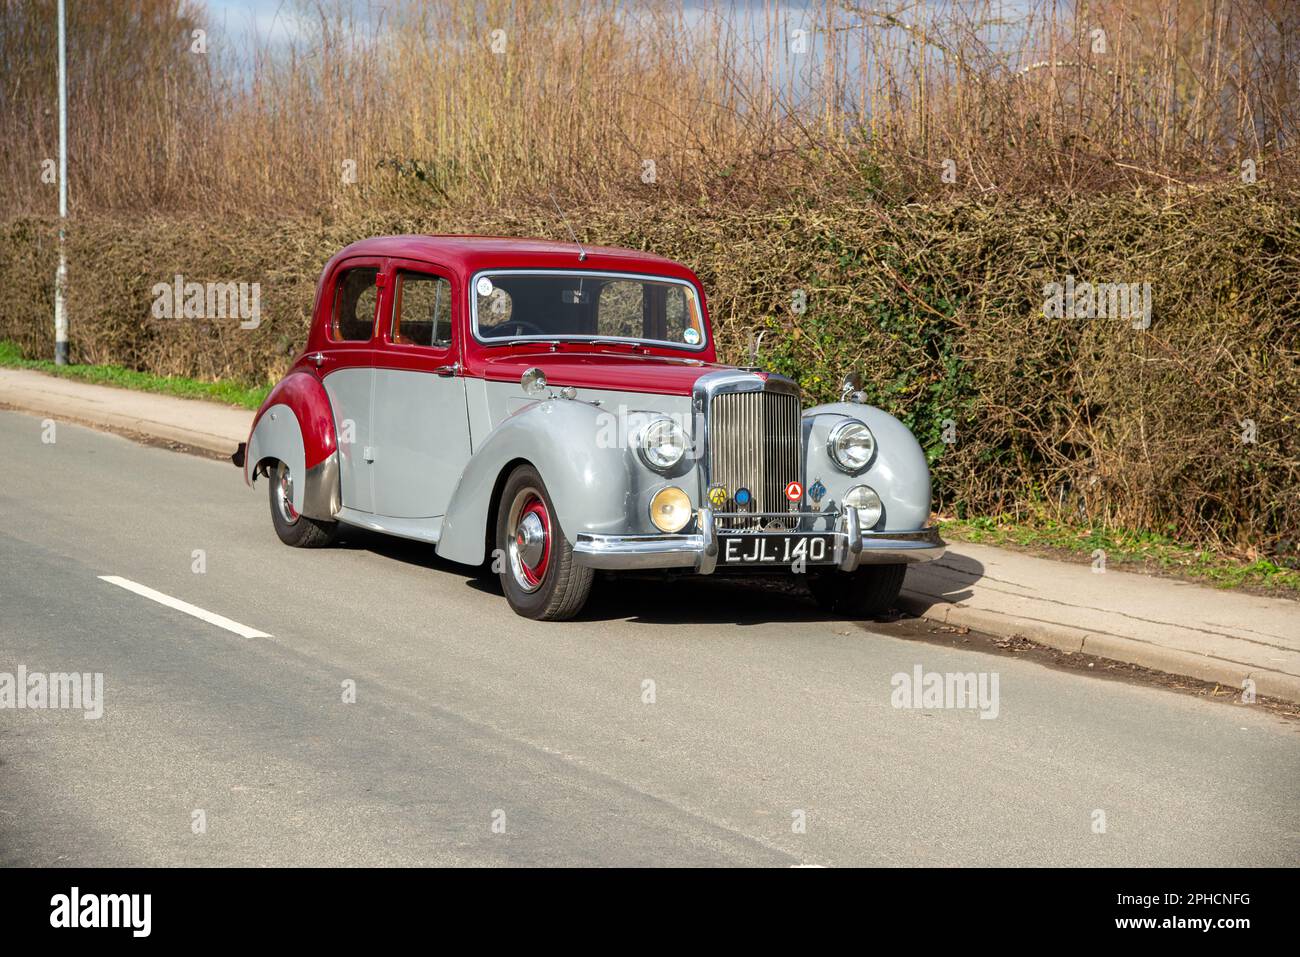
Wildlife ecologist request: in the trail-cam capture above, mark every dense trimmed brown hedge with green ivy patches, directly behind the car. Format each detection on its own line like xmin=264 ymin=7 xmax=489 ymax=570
xmin=0 ymin=186 xmax=1300 ymax=553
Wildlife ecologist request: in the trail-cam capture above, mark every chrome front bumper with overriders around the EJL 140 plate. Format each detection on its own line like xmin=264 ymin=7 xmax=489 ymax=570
xmin=573 ymin=508 xmax=945 ymax=575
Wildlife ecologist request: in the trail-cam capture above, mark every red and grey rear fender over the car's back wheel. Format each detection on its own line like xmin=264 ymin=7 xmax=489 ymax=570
xmin=244 ymin=372 xmax=339 ymax=519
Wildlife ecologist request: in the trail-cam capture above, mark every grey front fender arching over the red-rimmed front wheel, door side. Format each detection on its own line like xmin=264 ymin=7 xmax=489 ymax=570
xmin=437 ymin=399 xmax=665 ymax=564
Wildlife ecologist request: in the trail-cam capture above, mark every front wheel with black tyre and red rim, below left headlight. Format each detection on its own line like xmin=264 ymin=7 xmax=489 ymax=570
xmin=493 ymin=465 xmax=592 ymax=622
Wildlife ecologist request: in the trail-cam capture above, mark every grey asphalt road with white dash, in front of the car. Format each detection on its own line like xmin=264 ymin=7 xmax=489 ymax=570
xmin=0 ymin=413 xmax=1300 ymax=866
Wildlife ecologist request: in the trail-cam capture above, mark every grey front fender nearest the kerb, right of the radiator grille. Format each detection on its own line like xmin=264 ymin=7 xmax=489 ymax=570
xmin=803 ymin=402 xmax=930 ymax=532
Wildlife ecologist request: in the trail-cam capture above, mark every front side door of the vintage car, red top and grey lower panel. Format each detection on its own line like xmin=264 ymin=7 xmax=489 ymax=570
xmin=372 ymin=260 xmax=469 ymax=519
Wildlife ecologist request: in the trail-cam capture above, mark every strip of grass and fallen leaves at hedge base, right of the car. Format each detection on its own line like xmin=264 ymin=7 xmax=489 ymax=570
xmin=940 ymin=518 xmax=1300 ymax=598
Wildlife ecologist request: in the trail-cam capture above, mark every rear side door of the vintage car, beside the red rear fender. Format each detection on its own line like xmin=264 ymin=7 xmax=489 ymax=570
xmin=316 ymin=259 xmax=385 ymax=512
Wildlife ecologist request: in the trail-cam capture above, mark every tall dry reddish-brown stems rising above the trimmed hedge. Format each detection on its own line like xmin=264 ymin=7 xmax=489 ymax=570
xmin=0 ymin=0 xmax=1300 ymax=215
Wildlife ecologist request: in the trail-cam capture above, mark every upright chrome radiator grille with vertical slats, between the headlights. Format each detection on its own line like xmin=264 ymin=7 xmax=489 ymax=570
xmin=709 ymin=393 xmax=803 ymax=528
